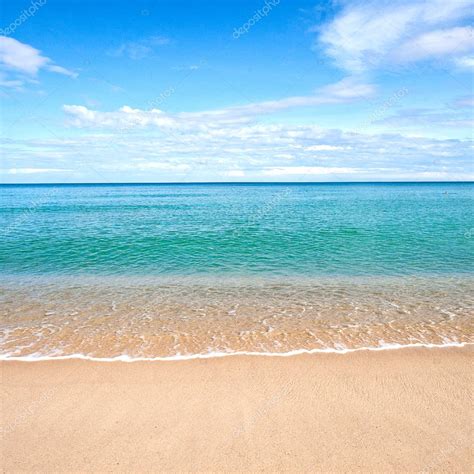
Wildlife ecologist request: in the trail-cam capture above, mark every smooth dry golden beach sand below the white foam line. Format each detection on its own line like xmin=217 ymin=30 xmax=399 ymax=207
xmin=1 ymin=347 xmax=473 ymax=472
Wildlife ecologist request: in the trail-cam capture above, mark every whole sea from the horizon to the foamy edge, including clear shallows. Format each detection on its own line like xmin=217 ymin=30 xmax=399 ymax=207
xmin=0 ymin=183 xmax=474 ymax=360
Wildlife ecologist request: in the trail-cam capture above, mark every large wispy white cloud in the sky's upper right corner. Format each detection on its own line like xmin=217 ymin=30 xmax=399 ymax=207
xmin=318 ymin=0 xmax=473 ymax=72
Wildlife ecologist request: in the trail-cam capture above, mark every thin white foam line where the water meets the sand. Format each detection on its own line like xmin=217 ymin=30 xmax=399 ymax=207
xmin=0 ymin=342 xmax=474 ymax=362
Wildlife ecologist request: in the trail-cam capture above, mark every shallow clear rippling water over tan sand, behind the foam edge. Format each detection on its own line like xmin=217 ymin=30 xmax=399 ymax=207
xmin=0 ymin=278 xmax=474 ymax=360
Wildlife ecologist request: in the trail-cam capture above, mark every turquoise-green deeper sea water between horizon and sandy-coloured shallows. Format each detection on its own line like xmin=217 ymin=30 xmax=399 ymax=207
xmin=0 ymin=183 xmax=474 ymax=276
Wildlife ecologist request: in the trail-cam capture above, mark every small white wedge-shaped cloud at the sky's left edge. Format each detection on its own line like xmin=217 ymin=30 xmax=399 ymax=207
xmin=0 ymin=36 xmax=77 ymax=87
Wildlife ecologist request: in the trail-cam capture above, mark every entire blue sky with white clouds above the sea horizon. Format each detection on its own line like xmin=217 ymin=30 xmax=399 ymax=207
xmin=0 ymin=0 xmax=474 ymax=183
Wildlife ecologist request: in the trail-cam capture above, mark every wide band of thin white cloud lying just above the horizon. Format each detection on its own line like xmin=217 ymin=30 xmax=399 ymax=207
xmin=2 ymin=124 xmax=474 ymax=181
